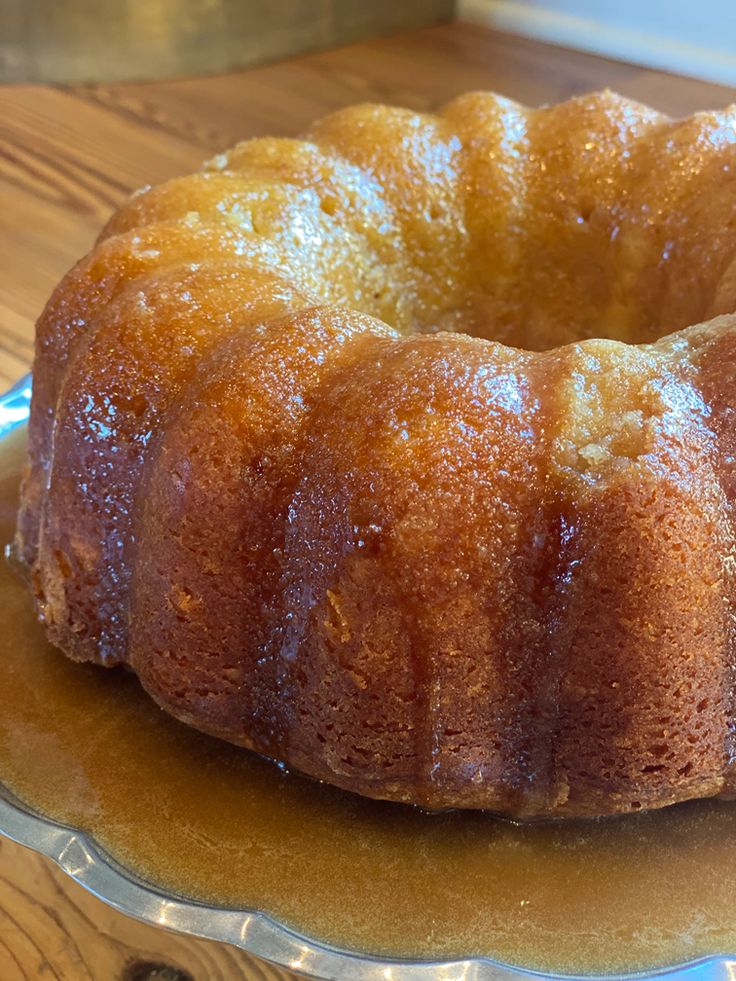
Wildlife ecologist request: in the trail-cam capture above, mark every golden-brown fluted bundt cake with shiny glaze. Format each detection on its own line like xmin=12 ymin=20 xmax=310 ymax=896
xmin=16 ymin=92 xmax=736 ymax=816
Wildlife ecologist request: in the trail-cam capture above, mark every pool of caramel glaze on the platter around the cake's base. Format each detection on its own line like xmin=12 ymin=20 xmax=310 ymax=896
xmin=0 ymin=432 xmax=736 ymax=972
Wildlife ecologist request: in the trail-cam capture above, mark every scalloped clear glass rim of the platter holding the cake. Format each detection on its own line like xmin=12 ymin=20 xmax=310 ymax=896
xmin=0 ymin=375 xmax=736 ymax=981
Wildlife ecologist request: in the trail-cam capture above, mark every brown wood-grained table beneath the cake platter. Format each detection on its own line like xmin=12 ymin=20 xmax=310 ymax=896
xmin=0 ymin=17 xmax=736 ymax=981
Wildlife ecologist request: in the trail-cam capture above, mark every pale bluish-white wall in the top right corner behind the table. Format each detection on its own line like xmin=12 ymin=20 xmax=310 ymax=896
xmin=458 ymin=0 xmax=736 ymax=86
